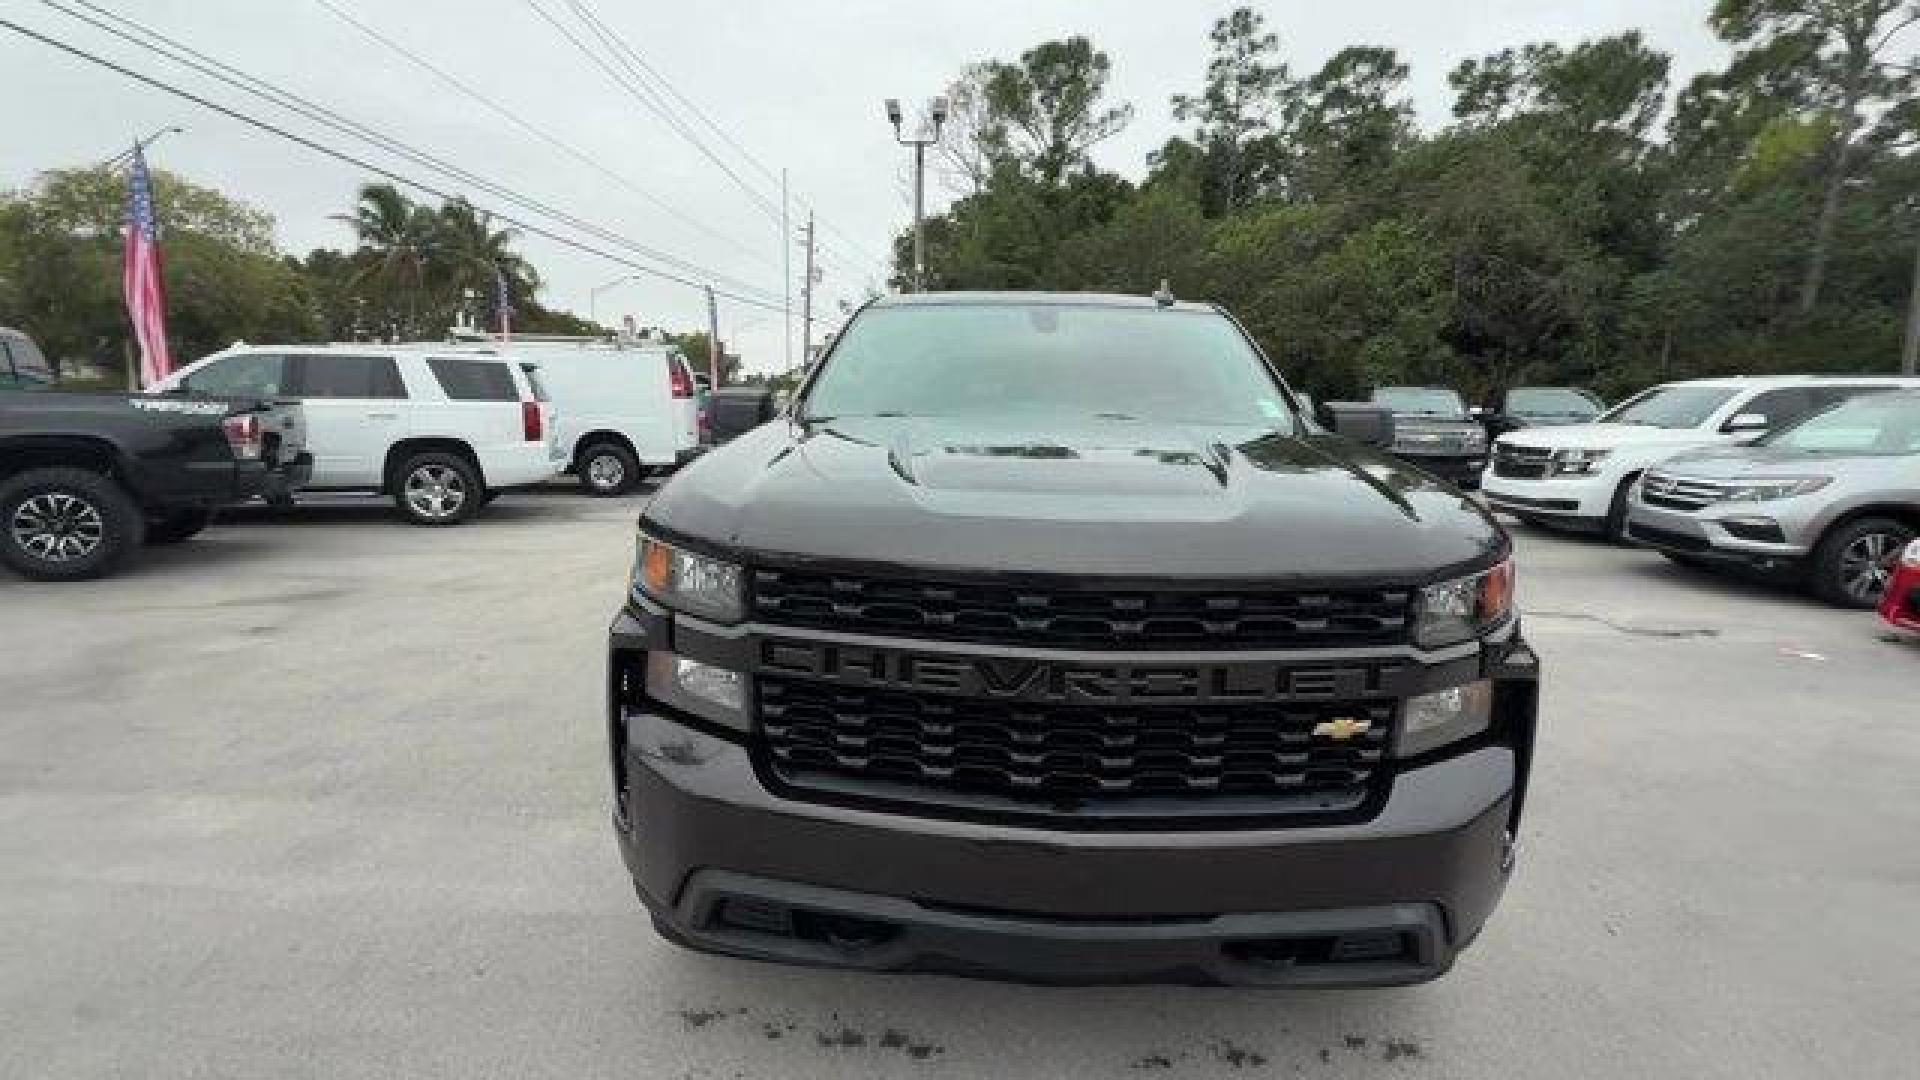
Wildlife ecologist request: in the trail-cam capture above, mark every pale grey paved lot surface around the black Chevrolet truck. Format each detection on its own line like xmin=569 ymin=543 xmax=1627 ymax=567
xmin=0 ymin=490 xmax=1920 ymax=1080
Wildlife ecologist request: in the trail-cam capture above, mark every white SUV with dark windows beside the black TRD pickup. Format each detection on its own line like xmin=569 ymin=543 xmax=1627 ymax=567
xmin=150 ymin=344 xmax=566 ymax=525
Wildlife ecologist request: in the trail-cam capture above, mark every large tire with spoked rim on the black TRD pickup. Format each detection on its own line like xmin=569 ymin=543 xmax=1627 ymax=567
xmin=0 ymin=469 xmax=146 ymax=580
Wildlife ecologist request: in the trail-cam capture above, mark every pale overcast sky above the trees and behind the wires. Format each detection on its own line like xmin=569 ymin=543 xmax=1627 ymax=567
xmin=0 ymin=0 xmax=1724 ymax=369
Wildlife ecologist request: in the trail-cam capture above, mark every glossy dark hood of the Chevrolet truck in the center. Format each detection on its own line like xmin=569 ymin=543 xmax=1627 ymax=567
xmin=643 ymin=419 xmax=1507 ymax=584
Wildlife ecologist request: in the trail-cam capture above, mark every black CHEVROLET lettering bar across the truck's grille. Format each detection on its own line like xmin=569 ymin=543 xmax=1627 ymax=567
xmin=758 ymin=640 xmax=1392 ymax=705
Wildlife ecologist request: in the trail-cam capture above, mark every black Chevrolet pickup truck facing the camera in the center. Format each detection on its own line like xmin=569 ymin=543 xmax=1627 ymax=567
xmin=607 ymin=294 xmax=1536 ymax=986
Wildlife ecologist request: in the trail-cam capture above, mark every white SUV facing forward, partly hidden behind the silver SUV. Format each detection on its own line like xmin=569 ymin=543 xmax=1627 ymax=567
xmin=1480 ymin=375 xmax=1920 ymax=540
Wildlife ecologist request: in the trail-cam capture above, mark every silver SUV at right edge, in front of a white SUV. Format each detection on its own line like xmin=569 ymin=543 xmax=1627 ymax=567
xmin=1628 ymin=390 xmax=1920 ymax=607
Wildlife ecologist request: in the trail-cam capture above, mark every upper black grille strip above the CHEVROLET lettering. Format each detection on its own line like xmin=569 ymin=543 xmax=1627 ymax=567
xmin=753 ymin=571 xmax=1411 ymax=650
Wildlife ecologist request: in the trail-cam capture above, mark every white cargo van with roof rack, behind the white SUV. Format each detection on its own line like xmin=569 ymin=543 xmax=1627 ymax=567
xmin=428 ymin=334 xmax=701 ymax=498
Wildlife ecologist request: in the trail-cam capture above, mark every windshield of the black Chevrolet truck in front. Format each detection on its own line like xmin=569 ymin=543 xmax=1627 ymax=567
xmin=801 ymin=304 xmax=1292 ymax=429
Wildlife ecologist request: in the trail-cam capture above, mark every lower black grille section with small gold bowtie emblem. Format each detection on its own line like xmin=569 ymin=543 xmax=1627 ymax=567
xmin=758 ymin=676 xmax=1394 ymax=817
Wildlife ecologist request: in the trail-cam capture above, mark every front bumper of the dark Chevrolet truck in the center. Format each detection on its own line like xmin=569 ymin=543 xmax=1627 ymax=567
xmin=609 ymin=599 xmax=1536 ymax=986
